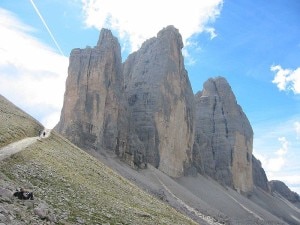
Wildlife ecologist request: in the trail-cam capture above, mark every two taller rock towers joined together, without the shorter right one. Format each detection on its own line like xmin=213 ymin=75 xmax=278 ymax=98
xmin=55 ymin=26 xmax=194 ymax=177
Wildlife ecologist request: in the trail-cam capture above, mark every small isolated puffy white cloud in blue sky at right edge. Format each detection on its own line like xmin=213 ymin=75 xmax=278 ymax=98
xmin=271 ymin=65 xmax=300 ymax=94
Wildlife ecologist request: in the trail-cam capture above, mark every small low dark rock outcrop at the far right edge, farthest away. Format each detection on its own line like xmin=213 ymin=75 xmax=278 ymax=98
xmin=269 ymin=180 xmax=300 ymax=203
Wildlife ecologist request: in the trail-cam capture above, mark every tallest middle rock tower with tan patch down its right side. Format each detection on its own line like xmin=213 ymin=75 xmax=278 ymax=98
xmin=123 ymin=26 xmax=194 ymax=177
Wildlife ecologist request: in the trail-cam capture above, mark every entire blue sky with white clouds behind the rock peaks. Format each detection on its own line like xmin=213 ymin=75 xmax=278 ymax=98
xmin=0 ymin=0 xmax=300 ymax=193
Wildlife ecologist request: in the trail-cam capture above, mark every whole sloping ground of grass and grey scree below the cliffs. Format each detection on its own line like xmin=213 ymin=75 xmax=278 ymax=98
xmin=0 ymin=85 xmax=300 ymax=225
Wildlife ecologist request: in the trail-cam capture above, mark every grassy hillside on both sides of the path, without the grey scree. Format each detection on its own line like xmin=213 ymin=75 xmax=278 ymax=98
xmin=0 ymin=96 xmax=195 ymax=225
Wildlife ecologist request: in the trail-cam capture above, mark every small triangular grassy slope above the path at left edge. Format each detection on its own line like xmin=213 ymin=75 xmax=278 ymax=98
xmin=0 ymin=95 xmax=43 ymax=148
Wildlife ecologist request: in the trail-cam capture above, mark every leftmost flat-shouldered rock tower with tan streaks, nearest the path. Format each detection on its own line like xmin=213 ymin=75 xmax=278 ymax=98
xmin=56 ymin=29 xmax=126 ymax=153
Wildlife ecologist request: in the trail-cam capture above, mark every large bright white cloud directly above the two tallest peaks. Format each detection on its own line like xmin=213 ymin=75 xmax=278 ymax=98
xmin=82 ymin=0 xmax=223 ymax=50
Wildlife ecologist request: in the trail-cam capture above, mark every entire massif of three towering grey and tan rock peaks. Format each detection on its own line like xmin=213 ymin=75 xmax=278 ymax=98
xmin=55 ymin=26 xmax=253 ymax=188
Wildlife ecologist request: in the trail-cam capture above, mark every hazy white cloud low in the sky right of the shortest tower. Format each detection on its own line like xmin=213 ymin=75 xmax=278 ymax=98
xmin=253 ymin=118 xmax=300 ymax=193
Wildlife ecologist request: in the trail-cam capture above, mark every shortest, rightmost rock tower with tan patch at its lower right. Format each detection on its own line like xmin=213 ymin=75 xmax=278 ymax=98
xmin=193 ymin=77 xmax=253 ymax=192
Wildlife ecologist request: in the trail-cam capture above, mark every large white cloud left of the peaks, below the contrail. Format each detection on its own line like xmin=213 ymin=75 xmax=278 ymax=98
xmin=0 ymin=8 xmax=68 ymax=128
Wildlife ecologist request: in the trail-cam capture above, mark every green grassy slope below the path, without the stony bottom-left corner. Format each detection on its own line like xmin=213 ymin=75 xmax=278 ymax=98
xmin=0 ymin=133 xmax=195 ymax=225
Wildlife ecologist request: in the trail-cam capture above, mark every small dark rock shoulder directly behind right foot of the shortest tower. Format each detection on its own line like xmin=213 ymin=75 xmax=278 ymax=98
xmin=252 ymin=155 xmax=270 ymax=192
